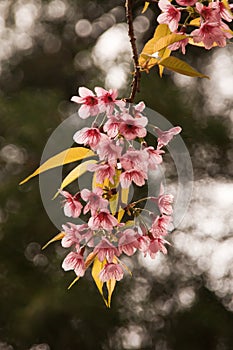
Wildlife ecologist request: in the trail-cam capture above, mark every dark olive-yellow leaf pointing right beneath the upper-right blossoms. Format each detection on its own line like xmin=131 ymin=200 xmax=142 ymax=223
xmin=159 ymin=56 xmax=209 ymax=79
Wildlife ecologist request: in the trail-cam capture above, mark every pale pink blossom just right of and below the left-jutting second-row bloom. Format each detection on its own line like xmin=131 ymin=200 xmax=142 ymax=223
xmin=97 ymin=137 xmax=122 ymax=164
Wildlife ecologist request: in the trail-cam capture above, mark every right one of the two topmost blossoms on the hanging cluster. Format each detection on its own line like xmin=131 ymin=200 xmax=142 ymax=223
xmin=95 ymin=87 xmax=125 ymax=114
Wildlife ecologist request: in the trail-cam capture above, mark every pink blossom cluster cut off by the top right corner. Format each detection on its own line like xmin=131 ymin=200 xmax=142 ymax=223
xmin=157 ymin=0 xmax=233 ymax=54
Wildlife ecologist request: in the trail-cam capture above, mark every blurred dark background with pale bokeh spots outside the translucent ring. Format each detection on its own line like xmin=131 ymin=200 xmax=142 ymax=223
xmin=0 ymin=0 xmax=233 ymax=350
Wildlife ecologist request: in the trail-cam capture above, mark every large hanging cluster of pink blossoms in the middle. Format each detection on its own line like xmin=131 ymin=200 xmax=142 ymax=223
xmin=60 ymin=87 xmax=181 ymax=283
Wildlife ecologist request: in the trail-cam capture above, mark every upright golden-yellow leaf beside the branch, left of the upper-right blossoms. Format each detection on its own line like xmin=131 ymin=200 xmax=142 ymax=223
xmin=139 ymin=24 xmax=171 ymax=71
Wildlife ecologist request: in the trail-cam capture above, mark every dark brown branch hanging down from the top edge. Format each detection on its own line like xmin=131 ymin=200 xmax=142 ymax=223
xmin=125 ymin=0 xmax=141 ymax=103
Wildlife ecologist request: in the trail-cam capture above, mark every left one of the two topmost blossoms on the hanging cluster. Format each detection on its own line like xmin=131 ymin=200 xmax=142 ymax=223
xmin=71 ymin=87 xmax=99 ymax=119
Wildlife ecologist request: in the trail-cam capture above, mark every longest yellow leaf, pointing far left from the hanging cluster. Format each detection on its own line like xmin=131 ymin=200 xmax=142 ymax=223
xmin=20 ymin=147 xmax=94 ymax=185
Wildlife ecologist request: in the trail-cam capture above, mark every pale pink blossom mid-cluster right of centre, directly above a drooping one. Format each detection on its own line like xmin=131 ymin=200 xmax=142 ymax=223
xmin=120 ymin=147 xmax=148 ymax=170
